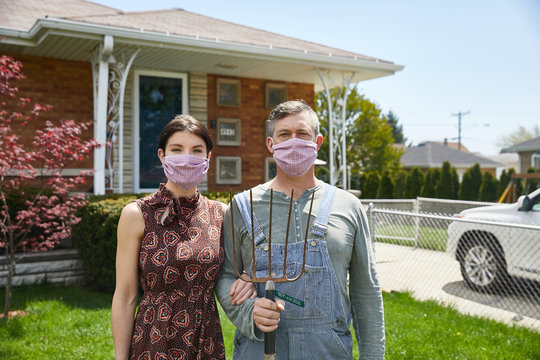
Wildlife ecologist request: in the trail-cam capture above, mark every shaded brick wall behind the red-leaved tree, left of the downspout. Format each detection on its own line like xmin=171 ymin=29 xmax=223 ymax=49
xmin=6 ymin=54 xmax=94 ymax=191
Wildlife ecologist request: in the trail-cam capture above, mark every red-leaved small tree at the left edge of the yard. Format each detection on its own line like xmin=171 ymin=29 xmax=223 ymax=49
xmin=0 ymin=56 xmax=97 ymax=319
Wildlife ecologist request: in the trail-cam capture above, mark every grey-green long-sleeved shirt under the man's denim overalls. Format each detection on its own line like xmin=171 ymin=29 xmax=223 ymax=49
xmin=216 ymin=182 xmax=385 ymax=359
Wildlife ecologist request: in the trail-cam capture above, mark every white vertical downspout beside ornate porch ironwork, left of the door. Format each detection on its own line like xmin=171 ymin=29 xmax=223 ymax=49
xmin=94 ymin=35 xmax=114 ymax=195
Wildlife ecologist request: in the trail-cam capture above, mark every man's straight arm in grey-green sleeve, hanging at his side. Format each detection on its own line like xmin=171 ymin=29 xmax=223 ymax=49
xmin=349 ymin=205 xmax=385 ymax=360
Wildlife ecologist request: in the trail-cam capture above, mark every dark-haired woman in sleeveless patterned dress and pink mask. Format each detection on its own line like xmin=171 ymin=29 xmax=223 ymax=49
xmin=111 ymin=115 xmax=256 ymax=360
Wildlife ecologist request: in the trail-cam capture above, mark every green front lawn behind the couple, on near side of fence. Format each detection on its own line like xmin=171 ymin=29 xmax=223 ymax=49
xmin=0 ymin=285 xmax=540 ymax=360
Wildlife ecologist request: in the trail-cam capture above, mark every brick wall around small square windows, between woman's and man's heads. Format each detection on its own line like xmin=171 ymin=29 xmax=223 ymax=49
xmin=207 ymin=75 xmax=315 ymax=192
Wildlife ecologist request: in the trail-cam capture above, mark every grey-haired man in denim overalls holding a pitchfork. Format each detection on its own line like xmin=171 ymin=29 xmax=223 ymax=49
xmin=217 ymin=101 xmax=385 ymax=360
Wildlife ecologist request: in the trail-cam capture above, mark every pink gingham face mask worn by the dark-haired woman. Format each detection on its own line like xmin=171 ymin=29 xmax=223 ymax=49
xmin=163 ymin=154 xmax=208 ymax=191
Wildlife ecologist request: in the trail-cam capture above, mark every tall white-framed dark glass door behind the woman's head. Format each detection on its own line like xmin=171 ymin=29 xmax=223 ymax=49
xmin=133 ymin=71 xmax=188 ymax=192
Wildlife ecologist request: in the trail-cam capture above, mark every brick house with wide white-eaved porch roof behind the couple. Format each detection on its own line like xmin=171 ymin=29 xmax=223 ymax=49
xmin=0 ymin=0 xmax=403 ymax=194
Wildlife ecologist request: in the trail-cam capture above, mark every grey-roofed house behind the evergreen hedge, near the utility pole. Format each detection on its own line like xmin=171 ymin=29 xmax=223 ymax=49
xmin=401 ymin=141 xmax=504 ymax=181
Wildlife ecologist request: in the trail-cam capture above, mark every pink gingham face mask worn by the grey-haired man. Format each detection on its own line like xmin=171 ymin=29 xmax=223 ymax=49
xmin=272 ymin=138 xmax=317 ymax=176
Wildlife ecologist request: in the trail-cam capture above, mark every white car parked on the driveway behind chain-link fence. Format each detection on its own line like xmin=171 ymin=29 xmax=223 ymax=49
xmin=446 ymin=189 xmax=540 ymax=292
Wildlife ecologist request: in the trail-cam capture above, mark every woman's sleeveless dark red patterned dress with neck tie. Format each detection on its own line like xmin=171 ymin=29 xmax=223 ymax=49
xmin=130 ymin=184 xmax=225 ymax=360
